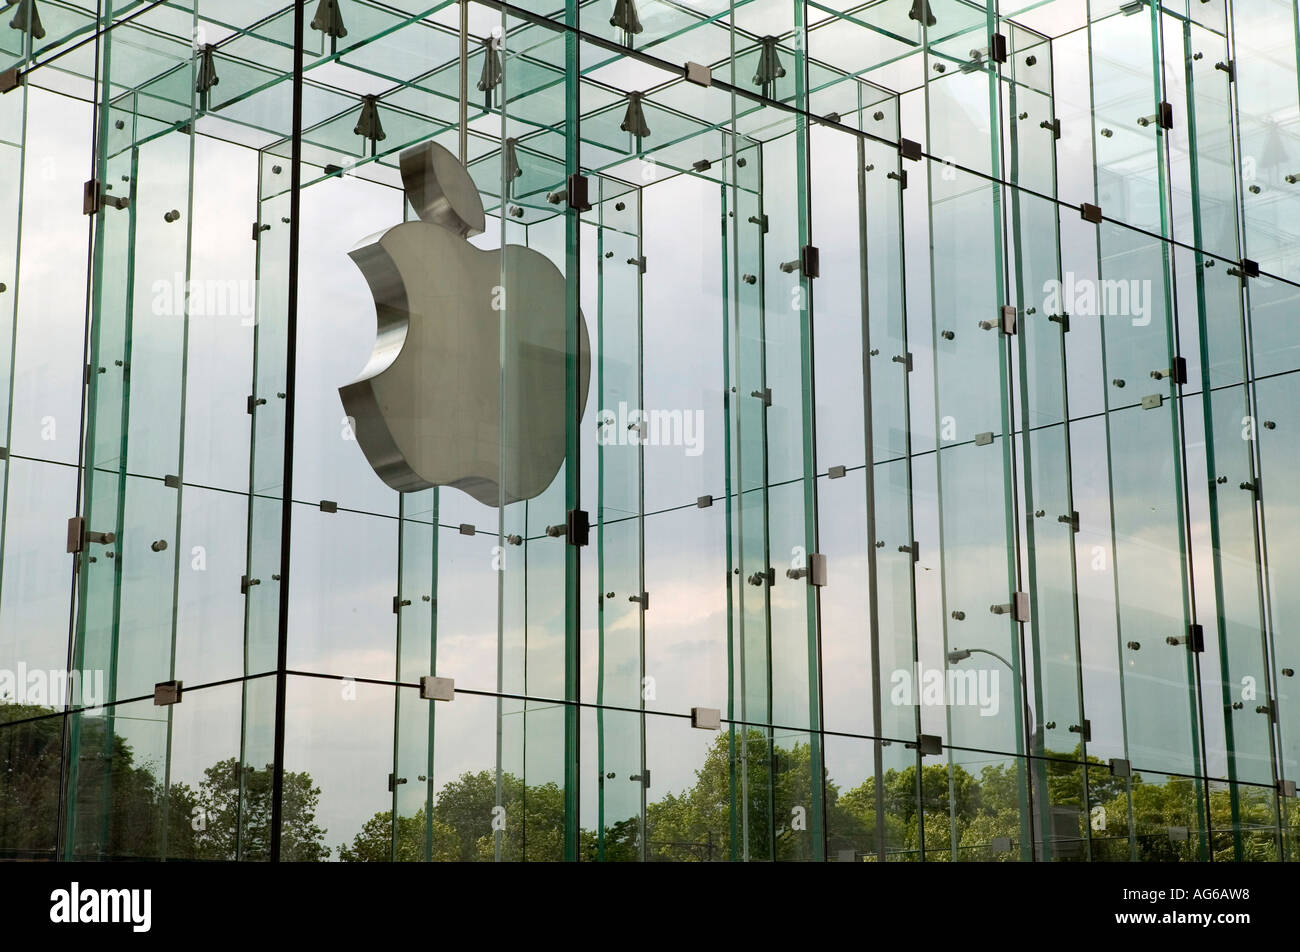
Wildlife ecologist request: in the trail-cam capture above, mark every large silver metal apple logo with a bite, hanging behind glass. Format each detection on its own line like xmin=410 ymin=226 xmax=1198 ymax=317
xmin=338 ymin=142 xmax=592 ymax=507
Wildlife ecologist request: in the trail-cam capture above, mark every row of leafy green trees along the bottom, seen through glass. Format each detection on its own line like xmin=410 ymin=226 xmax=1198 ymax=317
xmin=10 ymin=704 xmax=1300 ymax=862
